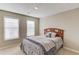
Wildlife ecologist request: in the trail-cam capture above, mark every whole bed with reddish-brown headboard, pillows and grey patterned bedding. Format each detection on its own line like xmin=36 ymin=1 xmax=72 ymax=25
xmin=20 ymin=28 xmax=64 ymax=55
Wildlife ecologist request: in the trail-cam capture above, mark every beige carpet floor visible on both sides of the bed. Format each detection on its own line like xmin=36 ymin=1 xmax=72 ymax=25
xmin=0 ymin=46 xmax=79 ymax=55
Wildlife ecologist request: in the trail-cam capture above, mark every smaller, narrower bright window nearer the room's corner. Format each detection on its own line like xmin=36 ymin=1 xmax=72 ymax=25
xmin=27 ymin=20 xmax=35 ymax=36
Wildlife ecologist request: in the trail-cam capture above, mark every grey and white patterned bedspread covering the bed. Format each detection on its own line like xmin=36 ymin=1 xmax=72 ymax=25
xmin=21 ymin=36 xmax=63 ymax=55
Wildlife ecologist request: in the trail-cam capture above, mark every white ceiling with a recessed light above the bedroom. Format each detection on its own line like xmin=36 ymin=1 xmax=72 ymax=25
xmin=0 ymin=3 xmax=79 ymax=18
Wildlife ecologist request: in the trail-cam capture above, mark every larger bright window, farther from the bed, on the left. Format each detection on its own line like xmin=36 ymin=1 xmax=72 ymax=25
xmin=4 ymin=17 xmax=19 ymax=40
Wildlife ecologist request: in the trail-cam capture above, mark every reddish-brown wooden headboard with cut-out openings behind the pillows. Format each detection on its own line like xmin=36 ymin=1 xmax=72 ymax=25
xmin=44 ymin=28 xmax=64 ymax=39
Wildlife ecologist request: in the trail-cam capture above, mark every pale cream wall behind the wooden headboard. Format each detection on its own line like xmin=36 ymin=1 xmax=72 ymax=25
xmin=40 ymin=9 xmax=79 ymax=51
